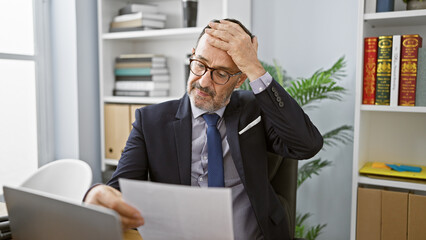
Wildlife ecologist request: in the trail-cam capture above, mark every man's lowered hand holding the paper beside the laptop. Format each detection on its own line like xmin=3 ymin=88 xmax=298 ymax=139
xmin=84 ymin=185 xmax=145 ymax=229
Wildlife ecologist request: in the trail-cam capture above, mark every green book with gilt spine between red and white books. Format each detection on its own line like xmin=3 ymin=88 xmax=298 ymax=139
xmin=375 ymin=36 xmax=392 ymax=105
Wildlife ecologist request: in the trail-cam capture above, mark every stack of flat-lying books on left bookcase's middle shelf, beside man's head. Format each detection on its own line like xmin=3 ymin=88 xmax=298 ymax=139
xmin=114 ymin=54 xmax=170 ymax=97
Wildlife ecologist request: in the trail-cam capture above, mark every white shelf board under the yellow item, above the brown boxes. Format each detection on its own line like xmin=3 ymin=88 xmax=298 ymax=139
xmin=358 ymin=176 xmax=426 ymax=191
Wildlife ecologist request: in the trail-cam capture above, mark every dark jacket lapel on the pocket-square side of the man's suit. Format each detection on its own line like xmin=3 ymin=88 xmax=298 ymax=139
xmin=224 ymin=91 xmax=245 ymax=183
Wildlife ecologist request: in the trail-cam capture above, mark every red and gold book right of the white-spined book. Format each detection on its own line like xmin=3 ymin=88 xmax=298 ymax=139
xmin=399 ymin=34 xmax=422 ymax=106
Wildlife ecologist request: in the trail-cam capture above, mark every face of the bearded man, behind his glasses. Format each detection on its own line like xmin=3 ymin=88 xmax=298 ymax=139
xmin=187 ymin=34 xmax=245 ymax=112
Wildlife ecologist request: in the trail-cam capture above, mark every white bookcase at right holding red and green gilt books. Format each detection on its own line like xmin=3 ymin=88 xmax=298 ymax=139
xmin=350 ymin=0 xmax=426 ymax=240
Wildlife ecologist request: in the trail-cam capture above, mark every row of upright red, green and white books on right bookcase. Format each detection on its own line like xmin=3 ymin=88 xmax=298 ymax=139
xmin=362 ymin=34 xmax=426 ymax=106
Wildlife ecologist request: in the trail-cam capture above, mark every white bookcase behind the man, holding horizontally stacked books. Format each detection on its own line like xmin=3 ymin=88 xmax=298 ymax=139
xmin=97 ymin=0 xmax=251 ymax=171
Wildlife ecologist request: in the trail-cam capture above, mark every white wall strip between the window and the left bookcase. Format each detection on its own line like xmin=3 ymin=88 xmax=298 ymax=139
xmin=50 ymin=0 xmax=101 ymax=182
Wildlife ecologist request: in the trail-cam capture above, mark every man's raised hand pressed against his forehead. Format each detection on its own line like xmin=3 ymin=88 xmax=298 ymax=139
xmin=205 ymin=20 xmax=266 ymax=81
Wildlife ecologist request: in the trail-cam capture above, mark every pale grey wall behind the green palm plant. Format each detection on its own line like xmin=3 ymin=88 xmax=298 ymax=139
xmin=252 ymin=0 xmax=358 ymax=240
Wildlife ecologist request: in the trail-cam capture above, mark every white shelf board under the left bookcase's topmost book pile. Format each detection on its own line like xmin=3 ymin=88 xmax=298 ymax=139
xmin=102 ymin=27 xmax=203 ymax=40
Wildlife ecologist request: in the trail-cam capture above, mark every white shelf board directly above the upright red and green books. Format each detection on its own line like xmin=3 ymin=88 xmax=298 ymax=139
xmin=364 ymin=10 xmax=426 ymax=27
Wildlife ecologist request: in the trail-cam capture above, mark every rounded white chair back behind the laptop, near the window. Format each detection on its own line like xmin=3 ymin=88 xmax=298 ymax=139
xmin=21 ymin=159 xmax=92 ymax=202
